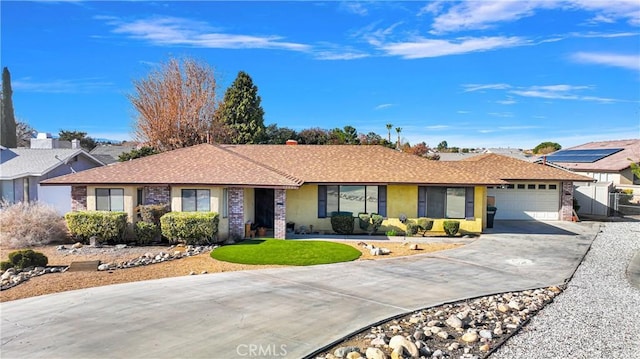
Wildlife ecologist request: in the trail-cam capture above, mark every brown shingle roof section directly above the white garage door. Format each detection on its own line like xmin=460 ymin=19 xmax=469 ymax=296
xmin=455 ymin=153 xmax=593 ymax=182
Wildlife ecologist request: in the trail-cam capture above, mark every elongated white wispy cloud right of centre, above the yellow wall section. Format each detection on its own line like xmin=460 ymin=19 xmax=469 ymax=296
xmin=373 ymin=36 xmax=529 ymax=59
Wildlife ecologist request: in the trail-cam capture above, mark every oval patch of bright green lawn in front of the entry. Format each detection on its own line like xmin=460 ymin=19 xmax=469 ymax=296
xmin=211 ymin=239 xmax=361 ymax=266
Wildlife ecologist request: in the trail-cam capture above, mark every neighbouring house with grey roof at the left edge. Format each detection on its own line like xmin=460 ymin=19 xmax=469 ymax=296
xmin=0 ymin=134 xmax=104 ymax=214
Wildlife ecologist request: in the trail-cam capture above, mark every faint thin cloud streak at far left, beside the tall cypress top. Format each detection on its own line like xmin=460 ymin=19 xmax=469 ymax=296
xmin=11 ymin=78 xmax=114 ymax=93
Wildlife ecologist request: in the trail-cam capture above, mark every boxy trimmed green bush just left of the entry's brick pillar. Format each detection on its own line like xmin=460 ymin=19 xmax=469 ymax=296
xmin=160 ymin=212 xmax=220 ymax=244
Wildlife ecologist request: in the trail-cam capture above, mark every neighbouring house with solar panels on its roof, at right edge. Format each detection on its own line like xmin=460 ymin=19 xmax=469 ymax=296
xmin=538 ymin=139 xmax=640 ymax=216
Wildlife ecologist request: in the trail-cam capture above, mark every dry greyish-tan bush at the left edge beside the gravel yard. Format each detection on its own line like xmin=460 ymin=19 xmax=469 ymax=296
xmin=0 ymin=201 xmax=67 ymax=248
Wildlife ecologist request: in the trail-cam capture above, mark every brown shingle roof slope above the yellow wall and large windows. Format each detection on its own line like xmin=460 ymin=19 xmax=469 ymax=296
xmin=224 ymin=145 xmax=503 ymax=185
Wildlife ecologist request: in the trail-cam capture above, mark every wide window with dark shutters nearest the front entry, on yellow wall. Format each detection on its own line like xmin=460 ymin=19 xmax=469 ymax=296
xmin=318 ymin=186 xmax=387 ymax=218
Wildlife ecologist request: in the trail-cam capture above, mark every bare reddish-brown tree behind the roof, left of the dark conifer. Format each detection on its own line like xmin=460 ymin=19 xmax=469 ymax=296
xmin=127 ymin=58 xmax=220 ymax=152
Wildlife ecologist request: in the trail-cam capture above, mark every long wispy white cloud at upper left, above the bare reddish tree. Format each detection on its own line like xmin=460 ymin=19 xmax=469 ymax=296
xmin=98 ymin=17 xmax=310 ymax=51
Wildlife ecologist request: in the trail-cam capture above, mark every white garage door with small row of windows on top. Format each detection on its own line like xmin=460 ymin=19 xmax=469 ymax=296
xmin=487 ymin=183 xmax=560 ymax=220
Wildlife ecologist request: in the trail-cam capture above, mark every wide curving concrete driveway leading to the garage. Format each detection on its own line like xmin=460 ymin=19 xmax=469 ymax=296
xmin=0 ymin=222 xmax=599 ymax=359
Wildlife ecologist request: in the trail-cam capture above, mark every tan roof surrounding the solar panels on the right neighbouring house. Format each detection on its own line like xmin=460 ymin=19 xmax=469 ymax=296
xmin=554 ymin=139 xmax=640 ymax=172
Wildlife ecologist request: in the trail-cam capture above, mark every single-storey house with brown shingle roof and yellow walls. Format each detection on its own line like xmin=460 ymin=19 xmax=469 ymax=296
xmin=40 ymin=142 xmax=586 ymax=239
